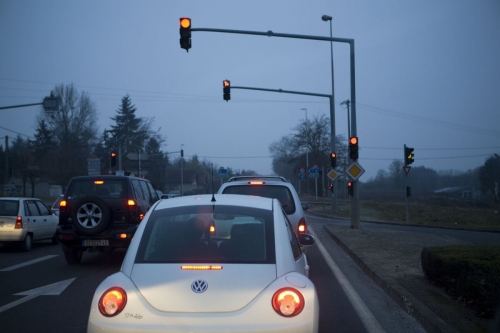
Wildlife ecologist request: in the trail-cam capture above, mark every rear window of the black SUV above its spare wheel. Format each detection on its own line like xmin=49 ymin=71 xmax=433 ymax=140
xmin=68 ymin=179 xmax=127 ymax=199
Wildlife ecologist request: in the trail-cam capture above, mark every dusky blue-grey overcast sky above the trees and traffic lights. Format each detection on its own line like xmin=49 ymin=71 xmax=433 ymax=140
xmin=0 ymin=0 xmax=500 ymax=181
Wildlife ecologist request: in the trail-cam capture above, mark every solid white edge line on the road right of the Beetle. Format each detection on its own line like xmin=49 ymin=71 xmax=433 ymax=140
xmin=309 ymin=226 xmax=385 ymax=332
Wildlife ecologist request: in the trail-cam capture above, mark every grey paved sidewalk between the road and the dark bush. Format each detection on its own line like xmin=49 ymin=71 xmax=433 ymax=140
xmin=309 ymin=212 xmax=494 ymax=332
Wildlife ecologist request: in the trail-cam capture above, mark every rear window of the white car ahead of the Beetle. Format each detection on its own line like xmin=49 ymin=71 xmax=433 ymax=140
xmin=222 ymin=185 xmax=296 ymax=215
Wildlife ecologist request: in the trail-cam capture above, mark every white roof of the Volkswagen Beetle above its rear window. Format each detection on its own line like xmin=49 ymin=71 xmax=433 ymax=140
xmin=155 ymin=194 xmax=276 ymax=210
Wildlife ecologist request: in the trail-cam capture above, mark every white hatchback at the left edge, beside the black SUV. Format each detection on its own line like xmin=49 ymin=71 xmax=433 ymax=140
xmin=0 ymin=197 xmax=59 ymax=251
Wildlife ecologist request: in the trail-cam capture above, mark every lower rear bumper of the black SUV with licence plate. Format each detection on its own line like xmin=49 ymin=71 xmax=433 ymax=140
xmin=56 ymin=225 xmax=138 ymax=248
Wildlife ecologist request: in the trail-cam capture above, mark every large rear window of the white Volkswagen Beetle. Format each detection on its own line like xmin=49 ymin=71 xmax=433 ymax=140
xmin=135 ymin=206 xmax=276 ymax=264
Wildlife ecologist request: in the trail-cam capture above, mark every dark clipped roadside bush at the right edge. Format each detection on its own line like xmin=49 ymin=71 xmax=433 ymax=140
xmin=421 ymin=245 xmax=500 ymax=318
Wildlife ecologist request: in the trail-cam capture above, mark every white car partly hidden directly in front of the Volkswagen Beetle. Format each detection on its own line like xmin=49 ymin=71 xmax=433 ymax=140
xmin=218 ymin=176 xmax=309 ymax=234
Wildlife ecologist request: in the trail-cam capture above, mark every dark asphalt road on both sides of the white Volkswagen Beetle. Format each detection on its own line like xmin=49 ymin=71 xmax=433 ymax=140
xmin=0 ymin=224 xmax=423 ymax=333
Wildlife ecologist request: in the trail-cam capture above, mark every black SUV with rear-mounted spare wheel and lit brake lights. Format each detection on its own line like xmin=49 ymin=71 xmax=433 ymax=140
xmin=56 ymin=175 xmax=158 ymax=265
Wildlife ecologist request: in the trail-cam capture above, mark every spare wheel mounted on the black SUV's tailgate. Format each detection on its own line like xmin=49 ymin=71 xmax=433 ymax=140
xmin=71 ymin=197 xmax=111 ymax=235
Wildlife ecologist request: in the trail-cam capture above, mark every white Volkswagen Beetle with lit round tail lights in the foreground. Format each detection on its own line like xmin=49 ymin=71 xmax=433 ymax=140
xmin=88 ymin=195 xmax=319 ymax=333
